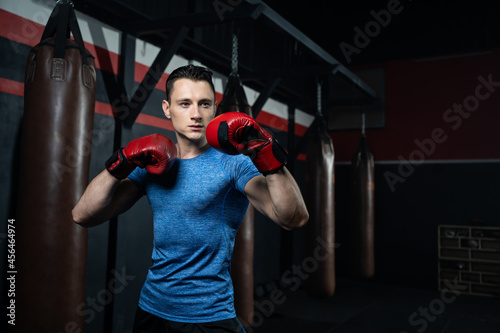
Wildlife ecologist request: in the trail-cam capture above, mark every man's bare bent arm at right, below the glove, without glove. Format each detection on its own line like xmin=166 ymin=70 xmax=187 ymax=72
xmin=245 ymin=167 xmax=309 ymax=230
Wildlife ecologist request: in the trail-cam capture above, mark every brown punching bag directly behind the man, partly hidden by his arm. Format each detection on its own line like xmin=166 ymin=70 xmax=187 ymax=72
xmin=216 ymin=73 xmax=255 ymax=328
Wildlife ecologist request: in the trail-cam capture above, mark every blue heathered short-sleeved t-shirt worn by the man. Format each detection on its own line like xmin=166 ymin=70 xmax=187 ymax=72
xmin=129 ymin=148 xmax=260 ymax=323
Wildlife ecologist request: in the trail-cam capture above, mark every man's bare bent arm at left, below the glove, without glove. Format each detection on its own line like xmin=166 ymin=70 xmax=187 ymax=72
xmin=72 ymin=170 xmax=142 ymax=227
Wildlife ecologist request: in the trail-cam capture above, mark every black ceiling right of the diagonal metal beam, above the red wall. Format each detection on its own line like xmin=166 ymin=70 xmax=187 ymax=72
xmin=265 ymin=0 xmax=500 ymax=66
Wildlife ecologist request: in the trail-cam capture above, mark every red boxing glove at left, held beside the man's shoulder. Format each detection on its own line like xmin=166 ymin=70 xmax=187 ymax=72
xmin=105 ymin=134 xmax=177 ymax=179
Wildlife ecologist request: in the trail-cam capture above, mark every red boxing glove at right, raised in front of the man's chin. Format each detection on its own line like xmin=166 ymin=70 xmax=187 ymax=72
xmin=206 ymin=112 xmax=288 ymax=175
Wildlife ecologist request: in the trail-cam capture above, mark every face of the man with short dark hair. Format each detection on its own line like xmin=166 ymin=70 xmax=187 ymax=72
xmin=162 ymin=79 xmax=215 ymax=144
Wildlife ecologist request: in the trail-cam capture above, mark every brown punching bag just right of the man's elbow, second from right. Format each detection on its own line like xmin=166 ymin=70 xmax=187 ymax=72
xmin=303 ymin=118 xmax=335 ymax=298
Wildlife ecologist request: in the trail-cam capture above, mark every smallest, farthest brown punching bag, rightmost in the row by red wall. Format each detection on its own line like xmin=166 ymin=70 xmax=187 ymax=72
xmin=350 ymin=134 xmax=375 ymax=279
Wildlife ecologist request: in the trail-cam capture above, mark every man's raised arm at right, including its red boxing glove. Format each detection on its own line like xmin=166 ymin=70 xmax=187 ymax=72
xmin=206 ymin=112 xmax=309 ymax=229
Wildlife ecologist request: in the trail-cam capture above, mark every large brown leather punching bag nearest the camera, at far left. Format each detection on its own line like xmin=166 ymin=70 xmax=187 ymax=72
xmin=15 ymin=3 xmax=96 ymax=333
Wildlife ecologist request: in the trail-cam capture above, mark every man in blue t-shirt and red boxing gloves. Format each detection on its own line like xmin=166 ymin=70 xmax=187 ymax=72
xmin=73 ymin=65 xmax=309 ymax=333
